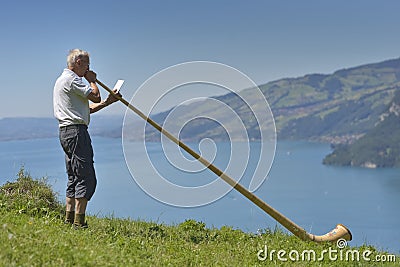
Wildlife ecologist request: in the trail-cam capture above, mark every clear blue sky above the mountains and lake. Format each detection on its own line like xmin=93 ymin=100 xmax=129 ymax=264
xmin=0 ymin=0 xmax=400 ymax=117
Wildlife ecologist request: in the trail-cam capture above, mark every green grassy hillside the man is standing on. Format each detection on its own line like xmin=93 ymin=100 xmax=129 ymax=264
xmin=0 ymin=170 xmax=400 ymax=266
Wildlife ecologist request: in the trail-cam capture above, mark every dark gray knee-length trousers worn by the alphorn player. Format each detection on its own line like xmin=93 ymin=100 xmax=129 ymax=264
xmin=60 ymin=124 xmax=97 ymax=200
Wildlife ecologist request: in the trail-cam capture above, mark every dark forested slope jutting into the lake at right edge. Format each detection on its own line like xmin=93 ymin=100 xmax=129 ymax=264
xmin=324 ymin=91 xmax=400 ymax=168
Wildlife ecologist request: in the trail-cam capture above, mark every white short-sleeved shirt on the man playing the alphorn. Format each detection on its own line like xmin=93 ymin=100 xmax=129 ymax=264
xmin=53 ymin=69 xmax=92 ymax=127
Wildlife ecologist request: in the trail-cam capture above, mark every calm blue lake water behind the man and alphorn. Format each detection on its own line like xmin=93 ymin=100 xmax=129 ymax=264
xmin=0 ymin=137 xmax=400 ymax=253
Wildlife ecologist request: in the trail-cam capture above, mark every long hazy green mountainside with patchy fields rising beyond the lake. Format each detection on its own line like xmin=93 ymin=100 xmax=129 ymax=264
xmin=130 ymin=59 xmax=400 ymax=143
